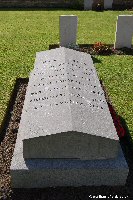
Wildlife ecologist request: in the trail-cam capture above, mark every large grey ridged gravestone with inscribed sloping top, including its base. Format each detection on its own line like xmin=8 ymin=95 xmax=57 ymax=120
xmin=10 ymin=47 xmax=129 ymax=188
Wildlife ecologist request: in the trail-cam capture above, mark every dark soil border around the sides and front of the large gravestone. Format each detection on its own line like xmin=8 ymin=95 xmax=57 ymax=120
xmin=0 ymin=45 xmax=133 ymax=200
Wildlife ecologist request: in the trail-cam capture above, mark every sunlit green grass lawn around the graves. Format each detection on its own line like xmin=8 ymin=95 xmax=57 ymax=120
xmin=0 ymin=9 xmax=133 ymax=138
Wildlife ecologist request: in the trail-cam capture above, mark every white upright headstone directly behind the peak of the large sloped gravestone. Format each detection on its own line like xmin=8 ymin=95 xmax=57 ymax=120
xmin=60 ymin=15 xmax=78 ymax=47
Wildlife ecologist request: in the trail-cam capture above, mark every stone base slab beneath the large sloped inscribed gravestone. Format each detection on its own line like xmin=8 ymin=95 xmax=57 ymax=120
xmin=10 ymin=131 xmax=129 ymax=188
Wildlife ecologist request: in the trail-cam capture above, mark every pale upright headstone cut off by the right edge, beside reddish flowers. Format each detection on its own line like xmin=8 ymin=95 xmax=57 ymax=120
xmin=114 ymin=15 xmax=133 ymax=49
